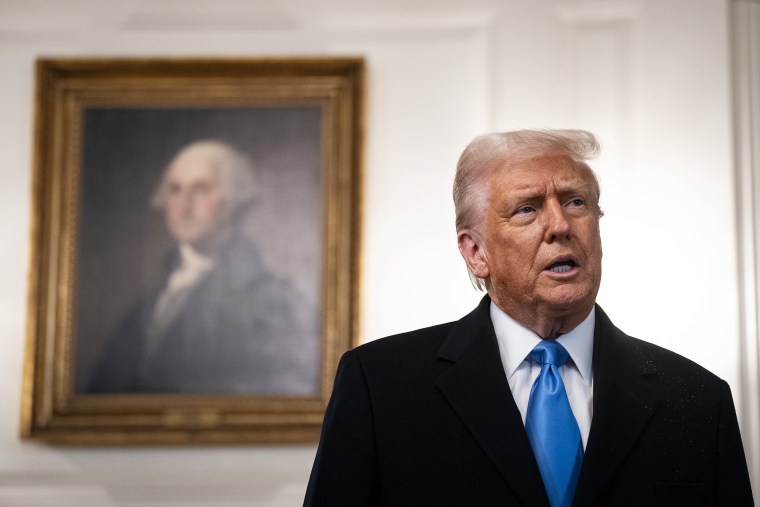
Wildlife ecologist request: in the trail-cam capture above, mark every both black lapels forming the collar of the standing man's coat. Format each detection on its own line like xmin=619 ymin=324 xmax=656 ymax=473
xmin=437 ymin=296 xmax=658 ymax=506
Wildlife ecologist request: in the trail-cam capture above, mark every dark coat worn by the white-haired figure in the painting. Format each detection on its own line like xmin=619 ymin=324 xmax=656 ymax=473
xmin=87 ymin=236 xmax=319 ymax=395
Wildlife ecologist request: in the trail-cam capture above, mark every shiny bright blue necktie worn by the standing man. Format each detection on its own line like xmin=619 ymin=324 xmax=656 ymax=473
xmin=525 ymin=340 xmax=583 ymax=507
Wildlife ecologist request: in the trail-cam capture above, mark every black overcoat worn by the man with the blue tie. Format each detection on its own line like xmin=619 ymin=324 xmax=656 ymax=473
xmin=305 ymin=297 xmax=752 ymax=507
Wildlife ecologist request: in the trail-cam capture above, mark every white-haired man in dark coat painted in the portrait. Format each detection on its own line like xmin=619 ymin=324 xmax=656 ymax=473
xmin=88 ymin=140 xmax=319 ymax=395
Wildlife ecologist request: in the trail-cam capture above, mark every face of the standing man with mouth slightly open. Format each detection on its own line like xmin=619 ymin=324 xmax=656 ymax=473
xmin=482 ymin=157 xmax=602 ymax=317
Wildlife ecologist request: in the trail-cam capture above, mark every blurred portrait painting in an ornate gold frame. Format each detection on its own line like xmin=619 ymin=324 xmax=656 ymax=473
xmin=17 ymin=58 xmax=364 ymax=444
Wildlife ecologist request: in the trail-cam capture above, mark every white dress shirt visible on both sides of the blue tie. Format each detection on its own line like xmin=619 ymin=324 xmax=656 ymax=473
xmin=491 ymin=302 xmax=595 ymax=449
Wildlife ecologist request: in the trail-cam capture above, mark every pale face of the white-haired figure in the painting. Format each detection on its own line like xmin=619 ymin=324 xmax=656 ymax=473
xmin=165 ymin=152 xmax=227 ymax=250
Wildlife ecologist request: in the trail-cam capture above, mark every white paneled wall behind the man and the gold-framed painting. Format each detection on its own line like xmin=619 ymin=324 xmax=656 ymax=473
xmin=0 ymin=0 xmax=752 ymax=506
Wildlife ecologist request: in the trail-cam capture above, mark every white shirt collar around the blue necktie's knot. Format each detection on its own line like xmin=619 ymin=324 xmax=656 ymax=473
xmin=490 ymin=301 xmax=596 ymax=385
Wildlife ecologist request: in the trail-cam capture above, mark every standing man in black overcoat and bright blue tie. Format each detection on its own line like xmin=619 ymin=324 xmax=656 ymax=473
xmin=305 ymin=131 xmax=752 ymax=507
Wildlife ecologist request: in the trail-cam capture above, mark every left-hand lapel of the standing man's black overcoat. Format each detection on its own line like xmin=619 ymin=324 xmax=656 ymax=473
xmin=437 ymin=296 xmax=549 ymax=506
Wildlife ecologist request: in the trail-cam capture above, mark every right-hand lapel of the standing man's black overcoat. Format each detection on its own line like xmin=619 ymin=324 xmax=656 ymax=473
xmin=574 ymin=306 xmax=658 ymax=505
